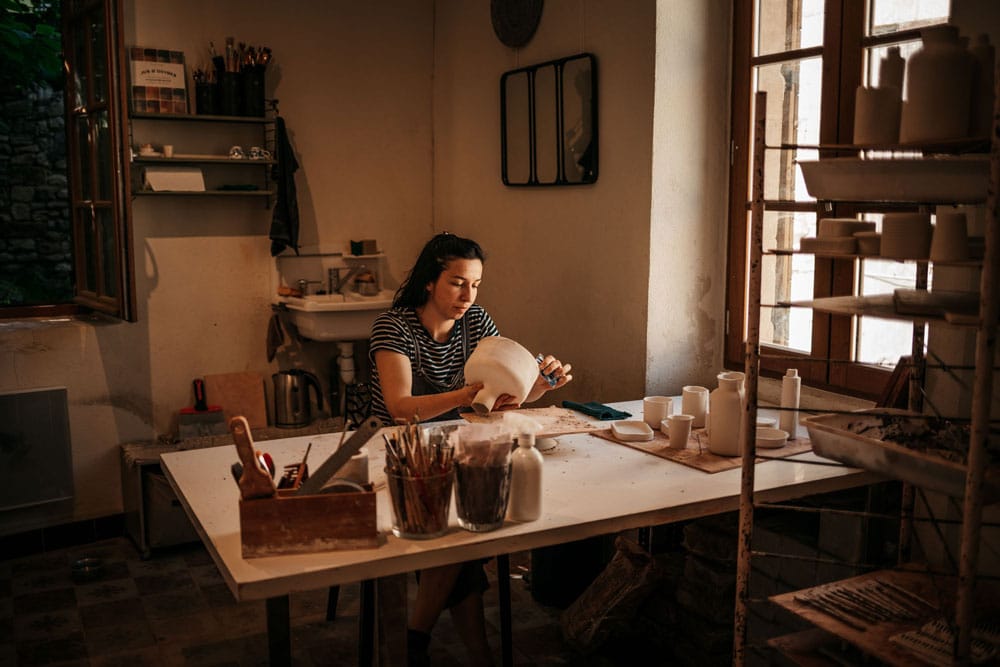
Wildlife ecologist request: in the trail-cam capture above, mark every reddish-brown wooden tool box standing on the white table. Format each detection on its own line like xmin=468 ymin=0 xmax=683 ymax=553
xmin=240 ymin=484 xmax=379 ymax=558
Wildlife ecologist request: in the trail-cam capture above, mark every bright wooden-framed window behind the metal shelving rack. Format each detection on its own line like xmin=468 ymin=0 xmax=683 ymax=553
xmin=726 ymin=0 xmax=950 ymax=397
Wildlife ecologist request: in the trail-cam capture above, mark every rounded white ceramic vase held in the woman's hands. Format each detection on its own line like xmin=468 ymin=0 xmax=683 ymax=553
xmin=465 ymin=336 xmax=538 ymax=415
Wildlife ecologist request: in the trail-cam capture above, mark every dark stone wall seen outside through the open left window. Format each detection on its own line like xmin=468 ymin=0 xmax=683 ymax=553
xmin=0 ymin=87 xmax=73 ymax=306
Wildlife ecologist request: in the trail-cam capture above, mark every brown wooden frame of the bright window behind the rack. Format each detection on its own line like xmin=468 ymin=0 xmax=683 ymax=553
xmin=724 ymin=0 xmax=944 ymax=399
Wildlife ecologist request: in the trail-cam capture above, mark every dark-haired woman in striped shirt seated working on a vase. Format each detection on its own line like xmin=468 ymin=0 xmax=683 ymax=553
xmin=369 ymin=233 xmax=573 ymax=665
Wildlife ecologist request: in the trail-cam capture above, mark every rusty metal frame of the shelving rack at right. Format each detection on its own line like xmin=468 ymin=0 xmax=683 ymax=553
xmin=733 ymin=87 xmax=1000 ymax=665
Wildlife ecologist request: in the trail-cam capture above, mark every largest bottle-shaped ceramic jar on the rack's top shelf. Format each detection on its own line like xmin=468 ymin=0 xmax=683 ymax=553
xmin=899 ymin=25 xmax=975 ymax=143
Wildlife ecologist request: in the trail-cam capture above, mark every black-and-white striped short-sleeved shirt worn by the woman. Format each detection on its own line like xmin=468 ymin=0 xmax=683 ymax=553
xmin=368 ymin=304 xmax=500 ymax=424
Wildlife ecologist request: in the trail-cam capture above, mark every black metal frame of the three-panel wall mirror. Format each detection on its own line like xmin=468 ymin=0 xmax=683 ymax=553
xmin=500 ymin=53 xmax=599 ymax=187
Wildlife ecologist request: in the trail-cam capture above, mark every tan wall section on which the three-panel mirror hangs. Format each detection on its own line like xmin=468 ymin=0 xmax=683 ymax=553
xmin=434 ymin=0 xmax=655 ymax=403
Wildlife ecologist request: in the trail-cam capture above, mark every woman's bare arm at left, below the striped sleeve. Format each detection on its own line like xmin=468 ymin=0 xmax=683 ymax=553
xmin=375 ymin=350 xmax=484 ymax=422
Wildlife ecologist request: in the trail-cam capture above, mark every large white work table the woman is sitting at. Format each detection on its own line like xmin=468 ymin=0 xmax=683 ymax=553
xmin=161 ymin=401 xmax=880 ymax=664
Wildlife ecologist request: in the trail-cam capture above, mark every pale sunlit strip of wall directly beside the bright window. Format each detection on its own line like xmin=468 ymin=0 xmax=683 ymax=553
xmin=646 ymin=0 xmax=732 ymax=395
